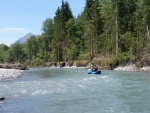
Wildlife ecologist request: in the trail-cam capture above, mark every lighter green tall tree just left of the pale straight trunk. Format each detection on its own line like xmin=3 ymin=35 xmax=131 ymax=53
xmin=100 ymin=0 xmax=115 ymax=54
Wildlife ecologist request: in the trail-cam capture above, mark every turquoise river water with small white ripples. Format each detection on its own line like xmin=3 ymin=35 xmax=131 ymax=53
xmin=0 ymin=68 xmax=150 ymax=113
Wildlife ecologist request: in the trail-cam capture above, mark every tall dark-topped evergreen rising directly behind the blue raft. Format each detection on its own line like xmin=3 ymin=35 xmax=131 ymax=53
xmin=84 ymin=0 xmax=103 ymax=58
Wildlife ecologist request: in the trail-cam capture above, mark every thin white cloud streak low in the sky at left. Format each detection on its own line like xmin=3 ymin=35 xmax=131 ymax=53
xmin=0 ymin=28 xmax=28 ymax=33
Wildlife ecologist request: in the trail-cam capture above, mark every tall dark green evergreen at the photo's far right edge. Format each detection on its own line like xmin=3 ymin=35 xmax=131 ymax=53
xmin=134 ymin=0 xmax=150 ymax=56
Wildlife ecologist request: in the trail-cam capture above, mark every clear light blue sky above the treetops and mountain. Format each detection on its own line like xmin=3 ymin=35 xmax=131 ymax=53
xmin=0 ymin=0 xmax=85 ymax=46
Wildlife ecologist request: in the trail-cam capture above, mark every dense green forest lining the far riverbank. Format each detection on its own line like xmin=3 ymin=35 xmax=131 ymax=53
xmin=0 ymin=0 xmax=150 ymax=65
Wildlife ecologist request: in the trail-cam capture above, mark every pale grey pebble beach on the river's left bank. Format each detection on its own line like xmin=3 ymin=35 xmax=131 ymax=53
xmin=0 ymin=68 xmax=23 ymax=80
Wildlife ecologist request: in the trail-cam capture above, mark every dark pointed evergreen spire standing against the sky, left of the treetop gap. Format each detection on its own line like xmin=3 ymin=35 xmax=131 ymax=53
xmin=53 ymin=0 xmax=73 ymax=62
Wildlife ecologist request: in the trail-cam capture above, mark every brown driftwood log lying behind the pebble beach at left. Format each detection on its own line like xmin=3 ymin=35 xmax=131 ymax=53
xmin=0 ymin=64 xmax=27 ymax=70
